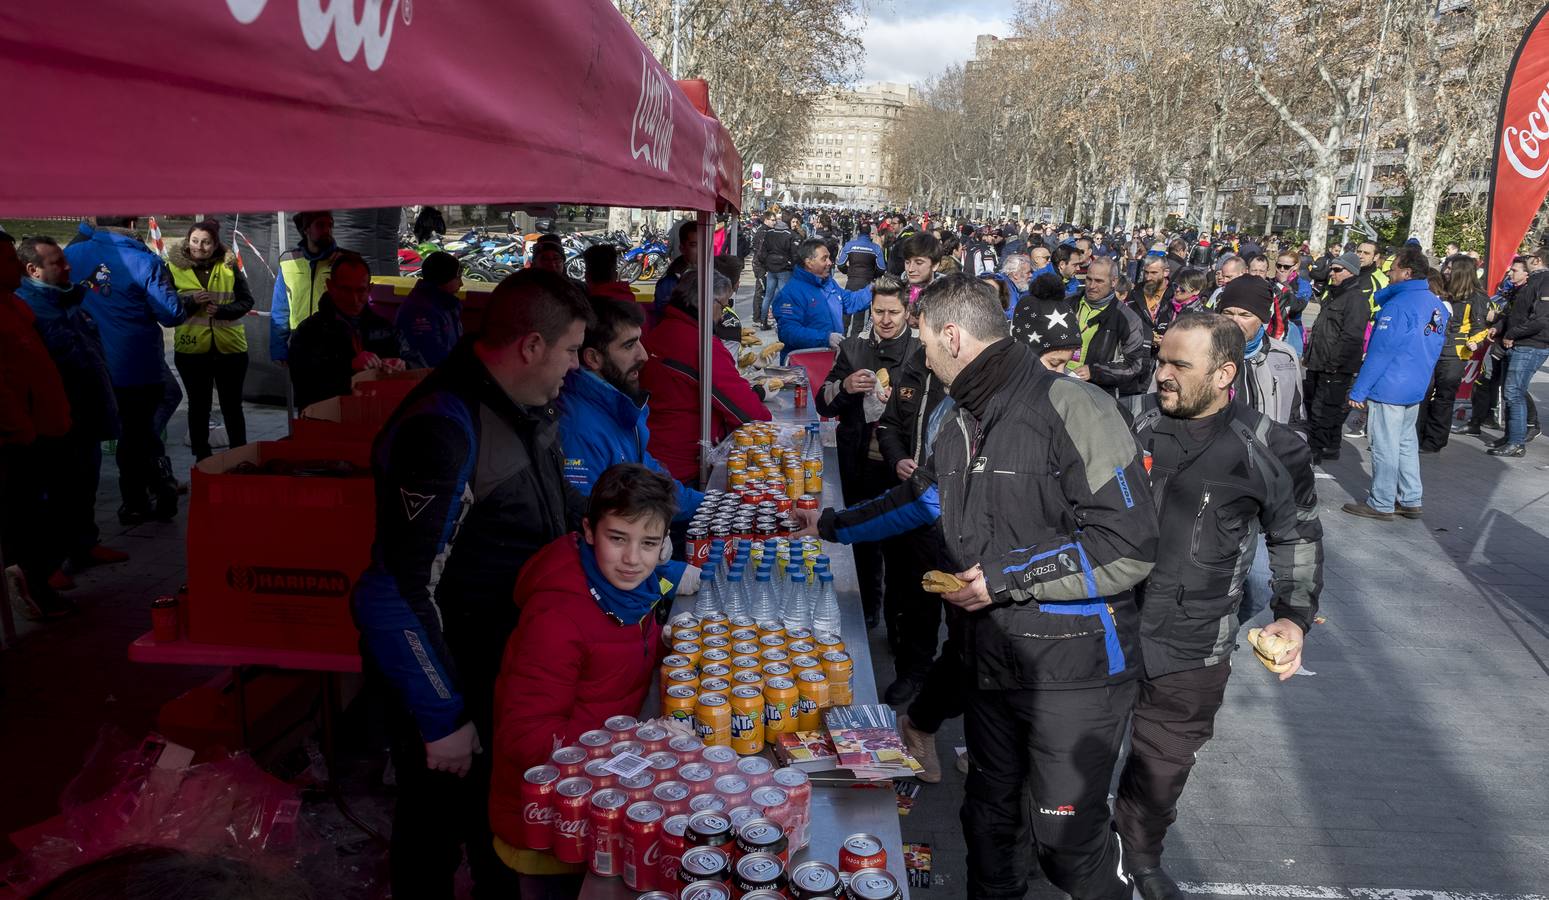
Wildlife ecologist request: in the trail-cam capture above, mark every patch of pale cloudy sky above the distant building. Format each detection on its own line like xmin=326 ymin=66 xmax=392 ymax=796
xmin=861 ymin=0 xmax=1015 ymax=84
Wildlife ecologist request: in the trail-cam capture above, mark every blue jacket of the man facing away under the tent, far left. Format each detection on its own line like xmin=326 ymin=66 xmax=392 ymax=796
xmin=65 ymin=222 xmax=186 ymax=387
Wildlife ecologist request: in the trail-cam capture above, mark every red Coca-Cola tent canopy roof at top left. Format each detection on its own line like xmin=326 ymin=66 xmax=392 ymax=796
xmin=0 ymin=0 xmax=742 ymax=217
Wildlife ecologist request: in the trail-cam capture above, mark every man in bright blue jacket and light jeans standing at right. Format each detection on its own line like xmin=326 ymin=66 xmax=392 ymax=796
xmin=1343 ymin=245 xmax=1450 ymax=522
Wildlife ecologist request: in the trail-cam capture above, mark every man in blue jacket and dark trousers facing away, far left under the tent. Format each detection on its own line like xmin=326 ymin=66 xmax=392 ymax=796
xmin=65 ymin=217 xmax=186 ymax=525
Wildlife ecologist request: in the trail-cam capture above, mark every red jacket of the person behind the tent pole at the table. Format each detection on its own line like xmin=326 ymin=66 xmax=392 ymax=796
xmin=640 ymin=307 xmax=770 ymax=483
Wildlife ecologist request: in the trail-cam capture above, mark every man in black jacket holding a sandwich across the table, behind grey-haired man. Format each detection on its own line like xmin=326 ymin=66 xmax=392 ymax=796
xmin=812 ymin=274 xmax=917 ymax=641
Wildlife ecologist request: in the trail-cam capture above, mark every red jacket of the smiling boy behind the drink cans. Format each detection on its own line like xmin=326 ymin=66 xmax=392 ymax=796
xmin=489 ymin=533 xmax=661 ymax=847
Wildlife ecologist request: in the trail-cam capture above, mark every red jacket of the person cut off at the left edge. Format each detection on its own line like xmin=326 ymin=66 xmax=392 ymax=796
xmin=0 ymin=291 xmax=70 ymax=446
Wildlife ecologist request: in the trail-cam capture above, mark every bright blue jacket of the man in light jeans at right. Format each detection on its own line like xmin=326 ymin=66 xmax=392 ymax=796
xmin=1351 ymin=279 xmax=1451 ymax=406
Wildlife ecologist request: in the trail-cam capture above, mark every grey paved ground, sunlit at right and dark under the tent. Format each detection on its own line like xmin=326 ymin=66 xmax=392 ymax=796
xmin=0 ymin=278 xmax=1549 ymax=900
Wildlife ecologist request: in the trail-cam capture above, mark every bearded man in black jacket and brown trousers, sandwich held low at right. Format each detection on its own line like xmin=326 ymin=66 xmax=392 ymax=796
xmin=1114 ymin=313 xmax=1323 ymax=900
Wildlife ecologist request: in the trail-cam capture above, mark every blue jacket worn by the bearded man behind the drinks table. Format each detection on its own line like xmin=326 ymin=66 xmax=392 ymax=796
xmin=558 ymin=369 xmax=705 ymax=522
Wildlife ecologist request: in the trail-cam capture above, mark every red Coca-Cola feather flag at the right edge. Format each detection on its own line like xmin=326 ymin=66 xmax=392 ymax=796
xmin=1484 ymin=6 xmax=1549 ymax=291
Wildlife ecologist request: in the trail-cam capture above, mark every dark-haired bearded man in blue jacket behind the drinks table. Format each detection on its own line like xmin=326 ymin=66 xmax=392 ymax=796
xmin=559 ymin=297 xmax=705 ymax=522
